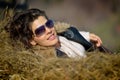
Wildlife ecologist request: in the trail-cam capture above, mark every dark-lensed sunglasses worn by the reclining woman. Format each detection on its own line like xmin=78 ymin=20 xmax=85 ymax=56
xmin=35 ymin=20 xmax=54 ymax=36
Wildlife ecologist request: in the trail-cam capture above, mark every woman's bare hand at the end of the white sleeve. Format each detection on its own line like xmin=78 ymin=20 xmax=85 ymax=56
xmin=90 ymin=33 xmax=102 ymax=47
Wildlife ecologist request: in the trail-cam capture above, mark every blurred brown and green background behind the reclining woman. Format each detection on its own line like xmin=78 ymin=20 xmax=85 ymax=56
xmin=0 ymin=0 xmax=120 ymax=52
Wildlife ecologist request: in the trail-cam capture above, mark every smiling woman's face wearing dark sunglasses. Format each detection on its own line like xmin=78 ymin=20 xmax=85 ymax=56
xmin=30 ymin=16 xmax=58 ymax=46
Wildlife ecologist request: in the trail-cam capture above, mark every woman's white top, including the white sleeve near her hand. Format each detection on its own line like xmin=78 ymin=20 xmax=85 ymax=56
xmin=58 ymin=31 xmax=90 ymax=58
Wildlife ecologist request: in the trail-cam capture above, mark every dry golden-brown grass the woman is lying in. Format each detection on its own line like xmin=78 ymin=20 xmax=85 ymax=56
xmin=0 ymin=9 xmax=120 ymax=80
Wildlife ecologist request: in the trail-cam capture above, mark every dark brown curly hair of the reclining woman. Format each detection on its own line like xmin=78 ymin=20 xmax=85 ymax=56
xmin=5 ymin=9 xmax=48 ymax=48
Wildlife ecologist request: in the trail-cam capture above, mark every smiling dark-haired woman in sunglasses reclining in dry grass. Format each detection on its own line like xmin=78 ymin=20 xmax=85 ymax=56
xmin=5 ymin=9 xmax=102 ymax=58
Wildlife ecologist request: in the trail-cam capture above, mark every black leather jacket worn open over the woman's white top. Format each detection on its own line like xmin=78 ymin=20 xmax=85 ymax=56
xmin=56 ymin=26 xmax=93 ymax=57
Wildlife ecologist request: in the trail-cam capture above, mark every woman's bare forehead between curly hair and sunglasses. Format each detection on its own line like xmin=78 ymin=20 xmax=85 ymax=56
xmin=32 ymin=16 xmax=47 ymax=32
